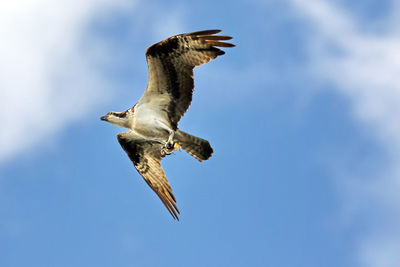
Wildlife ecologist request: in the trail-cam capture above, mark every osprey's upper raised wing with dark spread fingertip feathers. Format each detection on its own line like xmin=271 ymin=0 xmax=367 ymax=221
xmin=140 ymin=30 xmax=235 ymax=129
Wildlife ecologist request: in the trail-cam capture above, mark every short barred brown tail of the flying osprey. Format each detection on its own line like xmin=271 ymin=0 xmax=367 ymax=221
xmin=175 ymin=130 xmax=214 ymax=162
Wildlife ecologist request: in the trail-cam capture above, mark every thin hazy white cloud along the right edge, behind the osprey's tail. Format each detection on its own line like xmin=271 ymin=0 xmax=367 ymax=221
xmin=289 ymin=0 xmax=400 ymax=267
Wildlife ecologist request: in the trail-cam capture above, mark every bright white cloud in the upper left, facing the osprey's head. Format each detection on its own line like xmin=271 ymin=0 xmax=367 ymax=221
xmin=0 ymin=0 xmax=135 ymax=162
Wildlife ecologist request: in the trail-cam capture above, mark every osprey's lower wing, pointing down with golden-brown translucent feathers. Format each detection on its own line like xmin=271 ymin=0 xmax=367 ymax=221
xmin=117 ymin=131 xmax=179 ymax=221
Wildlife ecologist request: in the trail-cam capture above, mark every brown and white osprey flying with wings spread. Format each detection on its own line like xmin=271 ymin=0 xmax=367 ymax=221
xmin=101 ymin=30 xmax=235 ymax=220
